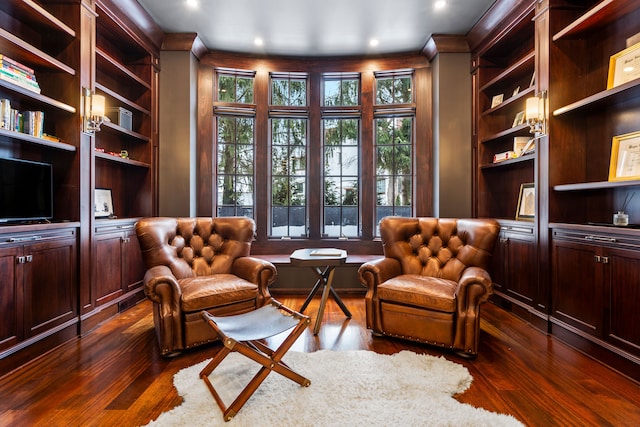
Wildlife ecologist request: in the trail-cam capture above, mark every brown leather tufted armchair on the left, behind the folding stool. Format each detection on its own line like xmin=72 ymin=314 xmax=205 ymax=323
xmin=136 ymin=217 xmax=276 ymax=356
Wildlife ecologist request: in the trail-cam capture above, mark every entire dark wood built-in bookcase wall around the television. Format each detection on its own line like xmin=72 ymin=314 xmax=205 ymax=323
xmin=0 ymin=0 xmax=163 ymax=375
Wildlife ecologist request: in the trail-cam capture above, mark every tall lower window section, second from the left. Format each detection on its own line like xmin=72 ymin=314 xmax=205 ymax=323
xmin=270 ymin=118 xmax=307 ymax=237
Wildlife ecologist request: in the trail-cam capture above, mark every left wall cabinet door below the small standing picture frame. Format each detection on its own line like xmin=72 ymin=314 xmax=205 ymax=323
xmin=93 ymin=231 xmax=123 ymax=307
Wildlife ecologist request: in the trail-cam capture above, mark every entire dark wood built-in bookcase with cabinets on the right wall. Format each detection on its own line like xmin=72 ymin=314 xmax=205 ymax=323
xmin=469 ymin=0 xmax=640 ymax=378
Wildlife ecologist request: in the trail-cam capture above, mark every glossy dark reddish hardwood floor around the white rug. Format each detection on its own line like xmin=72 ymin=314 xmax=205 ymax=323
xmin=0 ymin=295 xmax=640 ymax=427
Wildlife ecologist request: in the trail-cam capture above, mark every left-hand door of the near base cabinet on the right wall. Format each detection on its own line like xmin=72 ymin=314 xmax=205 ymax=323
xmin=551 ymin=240 xmax=604 ymax=337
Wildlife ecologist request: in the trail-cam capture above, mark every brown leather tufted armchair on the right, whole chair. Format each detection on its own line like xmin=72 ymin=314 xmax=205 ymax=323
xmin=358 ymin=217 xmax=500 ymax=357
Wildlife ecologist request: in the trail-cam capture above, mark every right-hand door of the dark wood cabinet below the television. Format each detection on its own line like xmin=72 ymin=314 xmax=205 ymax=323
xmin=23 ymin=237 xmax=78 ymax=336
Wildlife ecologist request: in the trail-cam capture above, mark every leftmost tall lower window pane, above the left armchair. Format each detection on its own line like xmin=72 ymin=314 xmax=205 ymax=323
xmin=216 ymin=117 xmax=254 ymax=216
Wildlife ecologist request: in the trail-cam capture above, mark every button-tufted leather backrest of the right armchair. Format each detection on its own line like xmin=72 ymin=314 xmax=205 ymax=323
xmin=380 ymin=217 xmax=496 ymax=282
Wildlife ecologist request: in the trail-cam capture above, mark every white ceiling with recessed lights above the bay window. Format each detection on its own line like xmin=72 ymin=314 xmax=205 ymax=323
xmin=138 ymin=0 xmax=495 ymax=56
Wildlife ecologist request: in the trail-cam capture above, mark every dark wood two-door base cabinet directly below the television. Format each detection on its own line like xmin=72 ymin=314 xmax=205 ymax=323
xmin=0 ymin=227 xmax=78 ymax=355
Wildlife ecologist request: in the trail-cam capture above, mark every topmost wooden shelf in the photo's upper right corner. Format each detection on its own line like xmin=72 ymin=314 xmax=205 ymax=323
xmin=553 ymin=0 xmax=640 ymax=42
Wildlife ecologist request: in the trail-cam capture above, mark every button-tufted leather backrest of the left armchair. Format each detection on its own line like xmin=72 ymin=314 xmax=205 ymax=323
xmin=139 ymin=217 xmax=256 ymax=279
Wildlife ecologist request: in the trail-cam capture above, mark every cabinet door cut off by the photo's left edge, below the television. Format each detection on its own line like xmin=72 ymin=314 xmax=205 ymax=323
xmin=0 ymin=247 xmax=22 ymax=350
